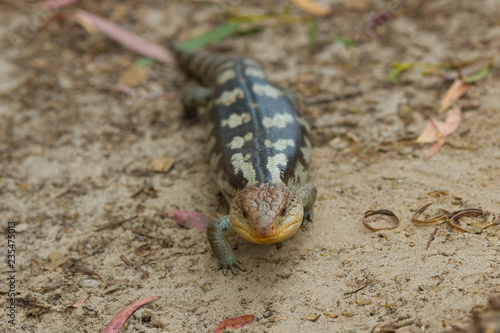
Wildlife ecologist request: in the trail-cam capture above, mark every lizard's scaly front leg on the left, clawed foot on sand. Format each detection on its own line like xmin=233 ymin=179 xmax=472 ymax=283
xmin=207 ymin=215 xmax=244 ymax=275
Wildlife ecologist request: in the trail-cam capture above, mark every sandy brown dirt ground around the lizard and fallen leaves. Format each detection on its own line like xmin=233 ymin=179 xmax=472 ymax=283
xmin=0 ymin=0 xmax=500 ymax=332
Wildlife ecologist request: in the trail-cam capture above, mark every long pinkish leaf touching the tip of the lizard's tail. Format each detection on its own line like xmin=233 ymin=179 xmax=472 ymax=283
xmin=75 ymin=10 xmax=177 ymax=64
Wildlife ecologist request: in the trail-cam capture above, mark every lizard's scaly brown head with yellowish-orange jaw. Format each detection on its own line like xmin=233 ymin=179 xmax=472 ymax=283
xmin=229 ymin=183 xmax=304 ymax=244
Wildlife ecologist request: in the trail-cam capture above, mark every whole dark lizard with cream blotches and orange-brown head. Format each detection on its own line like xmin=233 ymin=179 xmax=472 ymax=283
xmin=176 ymin=46 xmax=316 ymax=275
